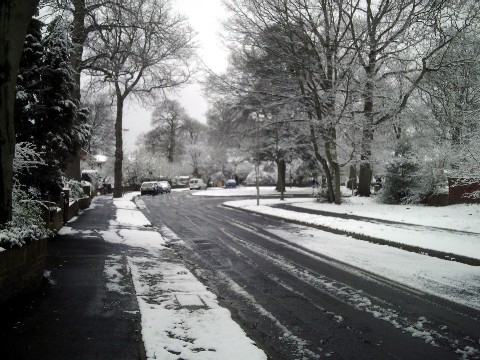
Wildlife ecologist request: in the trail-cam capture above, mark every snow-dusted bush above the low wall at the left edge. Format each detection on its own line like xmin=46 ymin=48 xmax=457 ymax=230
xmin=0 ymin=143 xmax=51 ymax=248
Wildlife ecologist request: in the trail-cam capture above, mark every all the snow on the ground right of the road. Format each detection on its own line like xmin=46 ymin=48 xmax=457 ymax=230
xmin=193 ymin=187 xmax=480 ymax=309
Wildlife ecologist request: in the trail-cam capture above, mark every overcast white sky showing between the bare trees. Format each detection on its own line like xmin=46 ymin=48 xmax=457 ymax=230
xmin=123 ymin=0 xmax=227 ymax=151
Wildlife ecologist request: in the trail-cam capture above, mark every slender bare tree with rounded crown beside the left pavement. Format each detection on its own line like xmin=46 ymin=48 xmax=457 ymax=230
xmin=86 ymin=0 xmax=195 ymax=197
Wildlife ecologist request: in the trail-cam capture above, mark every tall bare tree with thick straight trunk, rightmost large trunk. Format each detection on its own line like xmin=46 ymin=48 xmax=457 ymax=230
xmin=345 ymin=0 xmax=480 ymax=196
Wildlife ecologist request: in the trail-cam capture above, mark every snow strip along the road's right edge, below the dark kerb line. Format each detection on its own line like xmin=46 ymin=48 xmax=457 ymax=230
xmin=266 ymin=225 xmax=480 ymax=310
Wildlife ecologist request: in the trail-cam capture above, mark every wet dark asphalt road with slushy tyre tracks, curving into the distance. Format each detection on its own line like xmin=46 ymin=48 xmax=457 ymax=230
xmin=137 ymin=191 xmax=480 ymax=359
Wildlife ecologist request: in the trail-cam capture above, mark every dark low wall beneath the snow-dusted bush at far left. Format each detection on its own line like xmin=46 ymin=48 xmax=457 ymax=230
xmin=0 ymin=239 xmax=47 ymax=304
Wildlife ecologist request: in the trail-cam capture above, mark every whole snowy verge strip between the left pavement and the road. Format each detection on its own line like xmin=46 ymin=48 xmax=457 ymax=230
xmin=102 ymin=193 xmax=266 ymax=360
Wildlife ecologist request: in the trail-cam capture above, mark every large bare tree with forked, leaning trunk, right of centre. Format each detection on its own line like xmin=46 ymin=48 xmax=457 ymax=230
xmin=222 ymin=0 xmax=354 ymax=203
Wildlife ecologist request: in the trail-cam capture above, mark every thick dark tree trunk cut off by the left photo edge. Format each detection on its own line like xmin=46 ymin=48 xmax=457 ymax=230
xmin=0 ymin=0 xmax=39 ymax=224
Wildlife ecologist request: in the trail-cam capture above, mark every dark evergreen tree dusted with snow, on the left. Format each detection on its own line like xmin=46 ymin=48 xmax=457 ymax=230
xmin=15 ymin=16 xmax=88 ymax=200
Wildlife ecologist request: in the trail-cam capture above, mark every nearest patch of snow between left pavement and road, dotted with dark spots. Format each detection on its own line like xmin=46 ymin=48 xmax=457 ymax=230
xmin=128 ymin=257 xmax=266 ymax=360
